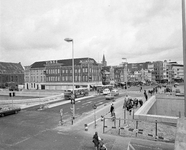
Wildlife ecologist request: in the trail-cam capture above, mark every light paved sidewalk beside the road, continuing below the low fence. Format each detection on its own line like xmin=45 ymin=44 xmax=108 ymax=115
xmin=56 ymin=91 xmax=174 ymax=150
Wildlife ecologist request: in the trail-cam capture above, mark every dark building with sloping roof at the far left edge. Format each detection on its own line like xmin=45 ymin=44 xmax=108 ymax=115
xmin=0 ymin=62 xmax=24 ymax=88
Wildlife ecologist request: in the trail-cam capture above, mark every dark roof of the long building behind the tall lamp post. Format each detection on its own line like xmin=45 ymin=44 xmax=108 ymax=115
xmin=31 ymin=57 xmax=98 ymax=69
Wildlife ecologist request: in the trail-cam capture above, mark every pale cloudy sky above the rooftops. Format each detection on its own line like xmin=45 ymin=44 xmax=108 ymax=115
xmin=0 ymin=0 xmax=183 ymax=66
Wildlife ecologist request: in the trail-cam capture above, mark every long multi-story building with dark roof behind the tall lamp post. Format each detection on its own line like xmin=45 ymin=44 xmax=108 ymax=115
xmin=25 ymin=58 xmax=102 ymax=90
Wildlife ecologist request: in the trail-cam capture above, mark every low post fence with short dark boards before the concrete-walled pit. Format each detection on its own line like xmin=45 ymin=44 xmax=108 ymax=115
xmin=103 ymin=118 xmax=176 ymax=142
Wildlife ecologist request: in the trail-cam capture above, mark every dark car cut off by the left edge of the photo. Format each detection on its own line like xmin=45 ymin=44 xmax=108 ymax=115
xmin=0 ymin=107 xmax=21 ymax=117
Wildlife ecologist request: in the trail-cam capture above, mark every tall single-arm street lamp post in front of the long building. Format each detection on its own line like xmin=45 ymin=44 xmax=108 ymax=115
xmin=64 ymin=38 xmax=75 ymax=124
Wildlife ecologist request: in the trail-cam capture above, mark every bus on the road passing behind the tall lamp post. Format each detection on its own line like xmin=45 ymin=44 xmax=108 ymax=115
xmin=64 ymin=88 xmax=89 ymax=99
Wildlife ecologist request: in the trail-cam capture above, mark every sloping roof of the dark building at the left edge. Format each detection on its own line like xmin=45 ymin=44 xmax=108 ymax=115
xmin=0 ymin=62 xmax=24 ymax=74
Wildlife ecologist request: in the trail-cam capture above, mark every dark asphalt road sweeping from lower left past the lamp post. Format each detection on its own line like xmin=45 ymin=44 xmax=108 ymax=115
xmin=0 ymin=93 xmax=129 ymax=150
